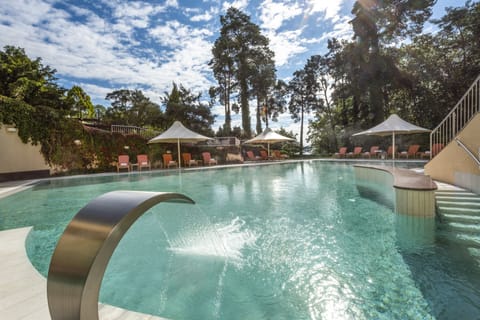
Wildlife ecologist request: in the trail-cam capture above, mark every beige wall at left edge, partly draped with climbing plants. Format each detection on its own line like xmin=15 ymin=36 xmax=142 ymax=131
xmin=0 ymin=124 xmax=50 ymax=174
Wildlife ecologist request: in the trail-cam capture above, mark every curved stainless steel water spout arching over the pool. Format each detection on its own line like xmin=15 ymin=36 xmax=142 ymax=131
xmin=47 ymin=191 xmax=195 ymax=320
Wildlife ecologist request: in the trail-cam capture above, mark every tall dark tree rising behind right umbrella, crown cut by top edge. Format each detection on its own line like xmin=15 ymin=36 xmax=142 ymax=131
xmin=351 ymin=0 xmax=435 ymax=123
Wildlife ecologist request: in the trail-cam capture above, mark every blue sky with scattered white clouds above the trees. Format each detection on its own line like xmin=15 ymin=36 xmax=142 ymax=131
xmin=0 ymin=0 xmax=464 ymax=136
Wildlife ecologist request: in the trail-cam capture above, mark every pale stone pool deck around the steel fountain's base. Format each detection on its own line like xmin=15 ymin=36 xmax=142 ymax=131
xmin=0 ymin=227 xmax=167 ymax=320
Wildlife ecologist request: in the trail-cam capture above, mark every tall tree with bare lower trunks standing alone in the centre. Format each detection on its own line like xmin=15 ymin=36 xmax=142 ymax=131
xmin=211 ymin=7 xmax=273 ymax=136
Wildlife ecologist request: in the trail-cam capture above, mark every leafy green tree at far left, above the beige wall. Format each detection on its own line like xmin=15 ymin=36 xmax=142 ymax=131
xmin=0 ymin=46 xmax=72 ymax=155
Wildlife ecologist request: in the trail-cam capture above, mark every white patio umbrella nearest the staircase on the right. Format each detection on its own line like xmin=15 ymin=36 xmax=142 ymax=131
xmin=353 ymin=114 xmax=431 ymax=160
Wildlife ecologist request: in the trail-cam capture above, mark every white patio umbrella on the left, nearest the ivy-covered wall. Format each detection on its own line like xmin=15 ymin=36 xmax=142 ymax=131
xmin=148 ymin=121 xmax=213 ymax=168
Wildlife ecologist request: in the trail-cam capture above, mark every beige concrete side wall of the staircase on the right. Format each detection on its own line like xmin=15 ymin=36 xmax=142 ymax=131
xmin=425 ymin=113 xmax=480 ymax=194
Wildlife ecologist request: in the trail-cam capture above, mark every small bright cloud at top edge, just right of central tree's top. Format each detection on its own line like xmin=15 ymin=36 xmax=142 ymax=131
xmin=260 ymin=0 xmax=302 ymax=30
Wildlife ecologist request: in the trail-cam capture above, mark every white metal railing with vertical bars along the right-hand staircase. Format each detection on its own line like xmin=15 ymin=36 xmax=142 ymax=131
xmin=430 ymin=75 xmax=480 ymax=159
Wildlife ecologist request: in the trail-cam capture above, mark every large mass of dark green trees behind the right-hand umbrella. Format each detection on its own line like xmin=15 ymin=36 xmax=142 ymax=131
xmin=308 ymin=0 xmax=480 ymax=153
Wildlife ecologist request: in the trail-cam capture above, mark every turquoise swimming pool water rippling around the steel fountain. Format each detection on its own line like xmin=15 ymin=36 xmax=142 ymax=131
xmin=0 ymin=161 xmax=480 ymax=319
